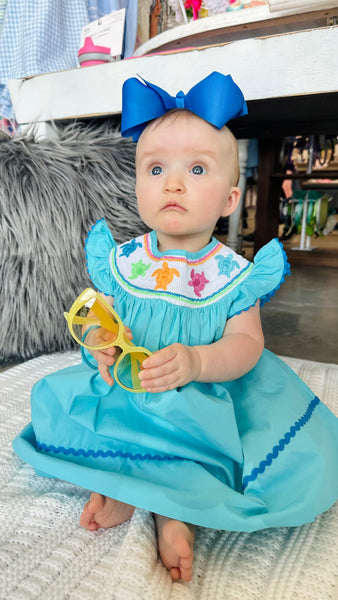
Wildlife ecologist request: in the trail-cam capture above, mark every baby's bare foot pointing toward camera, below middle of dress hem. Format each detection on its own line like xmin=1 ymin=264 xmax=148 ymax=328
xmin=155 ymin=515 xmax=195 ymax=581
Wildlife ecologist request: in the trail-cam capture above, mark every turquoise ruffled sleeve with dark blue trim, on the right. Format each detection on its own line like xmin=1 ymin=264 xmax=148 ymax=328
xmin=228 ymin=238 xmax=291 ymax=318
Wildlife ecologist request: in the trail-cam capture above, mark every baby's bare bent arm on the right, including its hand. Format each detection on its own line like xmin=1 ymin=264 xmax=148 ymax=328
xmin=140 ymin=302 xmax=264 ymax=392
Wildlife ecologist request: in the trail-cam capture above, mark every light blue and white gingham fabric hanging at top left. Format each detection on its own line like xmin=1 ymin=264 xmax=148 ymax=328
xmin=0 ymin=0 xmax=138 ymax=120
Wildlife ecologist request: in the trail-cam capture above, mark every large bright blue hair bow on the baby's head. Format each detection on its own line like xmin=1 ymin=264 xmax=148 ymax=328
xmin=121 ymin=71 xmax=248 ymax=142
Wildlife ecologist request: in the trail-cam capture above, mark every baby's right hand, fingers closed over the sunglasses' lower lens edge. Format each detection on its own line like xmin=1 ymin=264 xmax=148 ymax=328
xmin=140 ymin=344 xmax=201 ymax=392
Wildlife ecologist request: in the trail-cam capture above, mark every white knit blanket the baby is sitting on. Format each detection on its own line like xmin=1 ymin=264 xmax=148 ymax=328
xmin=0 ymin=352 xmax=338 ymax=600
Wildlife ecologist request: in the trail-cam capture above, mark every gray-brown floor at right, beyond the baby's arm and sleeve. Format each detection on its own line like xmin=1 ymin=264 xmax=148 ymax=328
xmin=261 ymin=264 xmax=338 ymax=364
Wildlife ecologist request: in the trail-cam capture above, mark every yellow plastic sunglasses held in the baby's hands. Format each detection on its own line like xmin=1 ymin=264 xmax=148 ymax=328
xmin=64 ymin=288 xmax=152 ymax=392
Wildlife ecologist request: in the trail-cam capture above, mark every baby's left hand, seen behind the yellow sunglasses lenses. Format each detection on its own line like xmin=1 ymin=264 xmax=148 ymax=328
xmin=86 ymin=327 xmax=133 ymax=386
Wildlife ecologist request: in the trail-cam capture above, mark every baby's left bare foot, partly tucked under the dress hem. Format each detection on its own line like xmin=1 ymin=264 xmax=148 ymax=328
xmin=80 ymin=492 xmax=135 ymax=531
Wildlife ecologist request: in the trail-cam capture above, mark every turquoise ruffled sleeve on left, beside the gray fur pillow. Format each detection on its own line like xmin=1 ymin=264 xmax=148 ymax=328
xmin=85 ymin=219 xmax=116 ymax=296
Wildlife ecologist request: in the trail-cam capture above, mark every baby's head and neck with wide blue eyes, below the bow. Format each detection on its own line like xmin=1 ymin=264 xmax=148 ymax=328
xmin=136 ymin=112 xmax=239 ymax=252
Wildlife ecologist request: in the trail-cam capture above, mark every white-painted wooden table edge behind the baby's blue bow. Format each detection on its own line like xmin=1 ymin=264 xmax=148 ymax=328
xmin=9 ymin=26 xmax=338 ymax=124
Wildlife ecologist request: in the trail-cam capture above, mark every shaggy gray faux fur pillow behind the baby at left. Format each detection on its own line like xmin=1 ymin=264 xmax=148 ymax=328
xmin=0 ymin=119 xmax=146 ymax=363
